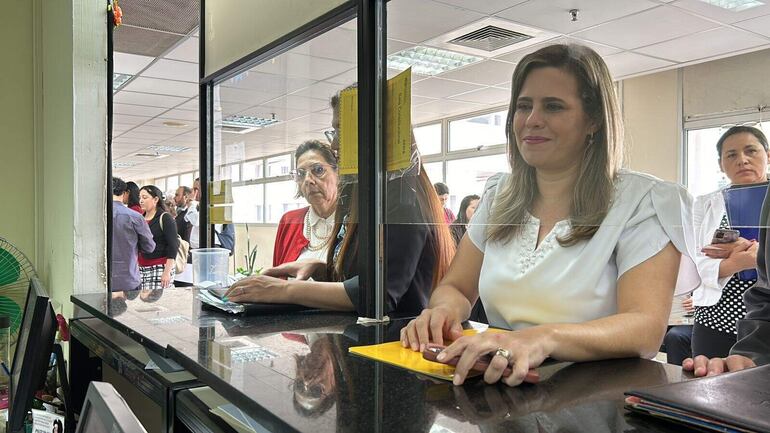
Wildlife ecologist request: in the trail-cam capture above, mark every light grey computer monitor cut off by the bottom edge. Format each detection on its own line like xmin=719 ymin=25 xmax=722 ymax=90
xmin=75 ymin=382 xmax=147 ymax=433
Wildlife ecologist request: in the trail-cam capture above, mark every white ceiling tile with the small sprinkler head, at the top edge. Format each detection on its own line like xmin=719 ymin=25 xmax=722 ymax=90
xmin=496 ymin=0 xmax=656 ymax=34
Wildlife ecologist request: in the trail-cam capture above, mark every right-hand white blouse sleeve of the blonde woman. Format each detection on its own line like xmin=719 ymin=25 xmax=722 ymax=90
xmin=615 ymin=181 xmax=700 ymax=294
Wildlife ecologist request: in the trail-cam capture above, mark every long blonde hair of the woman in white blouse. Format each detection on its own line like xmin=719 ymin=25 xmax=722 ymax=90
xmin=487 ymin=44 xmax=623 ymax=247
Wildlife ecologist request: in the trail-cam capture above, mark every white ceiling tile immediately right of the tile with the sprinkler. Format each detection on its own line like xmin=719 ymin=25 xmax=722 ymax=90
xmin=574 ymin=6 xmax=717 ymax=49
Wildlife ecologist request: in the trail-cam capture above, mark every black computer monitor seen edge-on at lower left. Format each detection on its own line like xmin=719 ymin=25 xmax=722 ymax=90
xmin=6 ymin=278 xmax=56 ymax=433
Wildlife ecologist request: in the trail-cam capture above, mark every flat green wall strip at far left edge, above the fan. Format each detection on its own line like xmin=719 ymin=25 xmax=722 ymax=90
xmin=0 ymin=0 xmax=36 ymax=262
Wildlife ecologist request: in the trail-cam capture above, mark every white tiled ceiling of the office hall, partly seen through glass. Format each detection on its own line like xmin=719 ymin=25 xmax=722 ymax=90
xmin=113 ymin=0 xmax=770 ymax=179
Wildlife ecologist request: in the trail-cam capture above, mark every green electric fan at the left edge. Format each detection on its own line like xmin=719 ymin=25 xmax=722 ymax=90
xmin=0 ymin=238 xmax=36 ymax=362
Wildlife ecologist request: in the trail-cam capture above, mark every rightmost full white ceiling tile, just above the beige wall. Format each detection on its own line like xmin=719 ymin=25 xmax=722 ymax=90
xmin=635 ymin=27 xmax=770 ymax=62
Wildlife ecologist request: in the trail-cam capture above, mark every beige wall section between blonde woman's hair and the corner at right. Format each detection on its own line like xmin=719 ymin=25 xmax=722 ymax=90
xmin=622 ymin=70 xmax=682 ymax=182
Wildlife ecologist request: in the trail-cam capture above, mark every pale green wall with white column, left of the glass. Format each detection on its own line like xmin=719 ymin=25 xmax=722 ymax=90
xmin=0 ymin=0 xmax=107 ymax=315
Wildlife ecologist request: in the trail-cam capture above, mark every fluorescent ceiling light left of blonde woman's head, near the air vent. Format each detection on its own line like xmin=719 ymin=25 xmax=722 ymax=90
xmin=388 ymin=45 xmax=483 ymax=75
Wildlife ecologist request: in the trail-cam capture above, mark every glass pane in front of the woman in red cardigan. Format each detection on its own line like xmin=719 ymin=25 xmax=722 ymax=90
xmin=209 ymin=12 xmax=358 ymax=311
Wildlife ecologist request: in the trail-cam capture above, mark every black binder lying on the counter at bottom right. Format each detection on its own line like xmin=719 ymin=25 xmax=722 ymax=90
xmin=626 ymin=365 xmax=770 ymax=432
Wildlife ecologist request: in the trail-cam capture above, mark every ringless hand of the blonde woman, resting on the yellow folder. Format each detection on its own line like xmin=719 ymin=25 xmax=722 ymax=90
xmin=401 ymin=306 xmax=463 ymax=352
